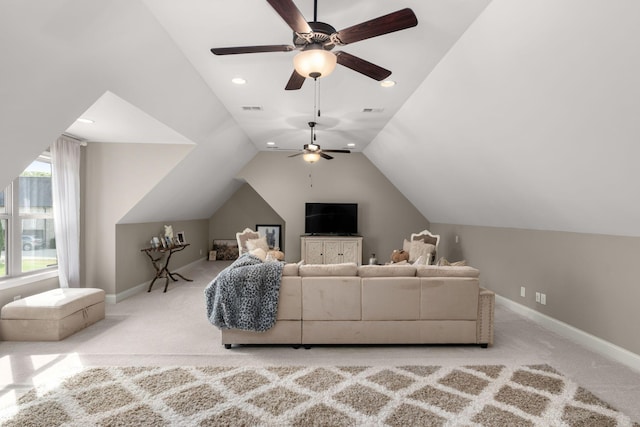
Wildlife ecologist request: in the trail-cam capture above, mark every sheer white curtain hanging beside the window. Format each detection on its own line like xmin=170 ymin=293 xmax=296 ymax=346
xmin=51 ymin=136 xmax=80 ymax=288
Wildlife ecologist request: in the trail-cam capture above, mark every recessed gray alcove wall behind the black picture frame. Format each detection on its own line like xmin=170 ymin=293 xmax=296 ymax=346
xmin=209 ymin=183 xmax=286 ymax=250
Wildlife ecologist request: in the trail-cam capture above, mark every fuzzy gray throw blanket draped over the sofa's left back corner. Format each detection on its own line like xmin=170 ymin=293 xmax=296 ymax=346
xmin=204 ymin=253 xmax=283 ymax=332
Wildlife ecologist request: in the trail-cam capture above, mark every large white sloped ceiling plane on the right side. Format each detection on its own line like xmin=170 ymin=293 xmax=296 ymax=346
xmin=365 ymin=0 xmax=640 ymax=236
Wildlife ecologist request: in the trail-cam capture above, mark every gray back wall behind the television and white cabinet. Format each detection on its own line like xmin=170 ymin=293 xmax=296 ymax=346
xmin=235 ymin=151 xmax=429 ymax=262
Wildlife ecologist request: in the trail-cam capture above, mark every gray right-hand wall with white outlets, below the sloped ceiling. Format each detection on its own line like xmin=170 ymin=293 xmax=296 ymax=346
xmin=432 ymin=224 xmax=640 ymax=354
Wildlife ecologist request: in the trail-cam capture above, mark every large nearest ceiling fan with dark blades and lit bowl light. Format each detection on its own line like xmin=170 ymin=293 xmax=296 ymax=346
xmin=211 ymin=0 xmax=418 ymax=90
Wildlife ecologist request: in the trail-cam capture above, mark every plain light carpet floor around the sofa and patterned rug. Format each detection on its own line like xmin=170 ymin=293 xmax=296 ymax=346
xmin=0 ymin=260 xmax=640 ymax=425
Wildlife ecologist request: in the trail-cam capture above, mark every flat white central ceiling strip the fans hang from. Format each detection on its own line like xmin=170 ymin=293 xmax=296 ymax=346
xmin=143 ymin=0 xmax=489 ymax=151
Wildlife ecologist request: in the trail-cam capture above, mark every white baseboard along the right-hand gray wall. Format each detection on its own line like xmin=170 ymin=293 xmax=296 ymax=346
xmin=496 ymin=295 xmax=640 ymax=372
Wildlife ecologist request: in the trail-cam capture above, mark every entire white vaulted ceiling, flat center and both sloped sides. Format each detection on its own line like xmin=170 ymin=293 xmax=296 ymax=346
xmin=0 ymin=0 xmax=640 ymax=236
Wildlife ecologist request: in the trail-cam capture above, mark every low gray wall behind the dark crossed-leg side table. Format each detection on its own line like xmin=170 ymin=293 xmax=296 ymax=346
xmin=116 ymin=219 xmax=209 ymax=295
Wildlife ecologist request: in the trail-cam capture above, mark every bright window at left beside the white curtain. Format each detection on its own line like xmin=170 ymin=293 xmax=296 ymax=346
xmin=0 ymin=152 xmax=58 ymax=279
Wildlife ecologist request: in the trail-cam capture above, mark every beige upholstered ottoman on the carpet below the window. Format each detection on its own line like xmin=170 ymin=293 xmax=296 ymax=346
xmin=0 ymin=288 xmax=105 ymax=341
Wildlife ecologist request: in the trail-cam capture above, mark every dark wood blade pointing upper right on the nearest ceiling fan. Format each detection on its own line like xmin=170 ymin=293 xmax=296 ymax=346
xmin=336 ymin=8 xmax=418 ymax=45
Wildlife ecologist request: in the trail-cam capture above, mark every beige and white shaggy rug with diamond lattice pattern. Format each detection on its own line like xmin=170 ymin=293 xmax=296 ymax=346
xmin=0 ymin=365 xmax=638 ymax=427
